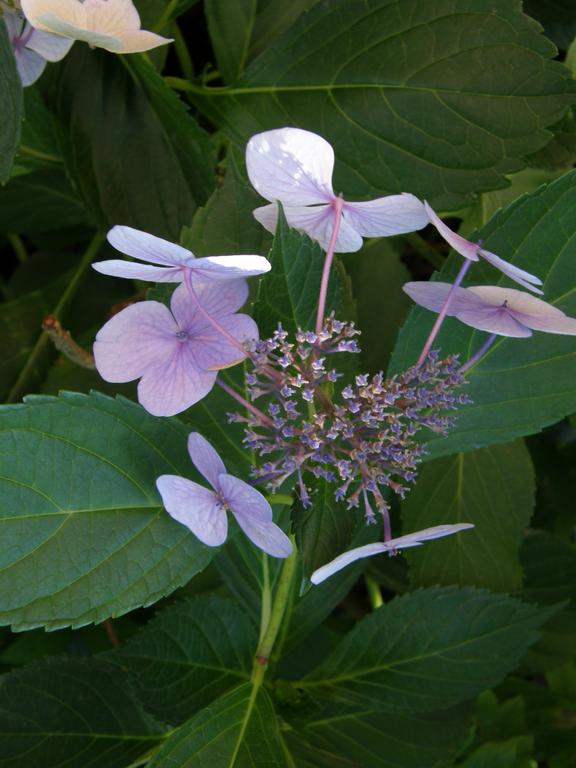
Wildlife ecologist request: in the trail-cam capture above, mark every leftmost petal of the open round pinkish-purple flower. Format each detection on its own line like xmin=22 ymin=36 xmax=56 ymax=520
xmin=94 ymin=301 xmax=178 ymax=383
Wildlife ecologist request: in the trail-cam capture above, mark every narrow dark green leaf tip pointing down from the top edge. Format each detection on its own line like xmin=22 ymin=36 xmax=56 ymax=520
xmin=204 ymin=0 xmax=257 ymax=83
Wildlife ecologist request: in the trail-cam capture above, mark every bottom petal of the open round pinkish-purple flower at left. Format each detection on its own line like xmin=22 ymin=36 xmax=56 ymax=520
xmin=138 ymin=342 xmax=217 ymax=416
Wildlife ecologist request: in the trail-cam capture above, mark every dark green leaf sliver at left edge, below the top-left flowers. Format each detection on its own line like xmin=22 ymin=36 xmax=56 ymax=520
xmin=0 ymin=19 xmax=23 ymax=184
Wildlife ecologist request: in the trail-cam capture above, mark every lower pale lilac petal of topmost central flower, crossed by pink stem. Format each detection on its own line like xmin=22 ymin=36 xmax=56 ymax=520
xmin=253 ymin=203 xmax=363 ymax=253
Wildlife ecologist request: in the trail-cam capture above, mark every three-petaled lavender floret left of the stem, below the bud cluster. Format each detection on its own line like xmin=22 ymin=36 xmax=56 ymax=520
xmin=156 ymin=432 xmax=292 ymax=557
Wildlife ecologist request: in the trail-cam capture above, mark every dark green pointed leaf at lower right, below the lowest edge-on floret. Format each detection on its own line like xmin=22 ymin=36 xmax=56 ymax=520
xmin=296 ymin=587 xmax=553 ymax=713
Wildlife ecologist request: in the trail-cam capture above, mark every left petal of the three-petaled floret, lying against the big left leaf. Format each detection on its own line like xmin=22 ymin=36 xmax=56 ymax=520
xmin=156 ymin=475 xmax=228 ymax=547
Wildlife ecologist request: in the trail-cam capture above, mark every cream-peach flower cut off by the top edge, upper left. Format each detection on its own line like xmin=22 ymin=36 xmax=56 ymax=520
xmin=21 ymin=0 xmax=172 ymax=53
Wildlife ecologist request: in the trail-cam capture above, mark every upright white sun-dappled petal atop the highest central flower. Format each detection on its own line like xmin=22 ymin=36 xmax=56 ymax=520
xmin=246 ymin=128 xmax=334 ymax=206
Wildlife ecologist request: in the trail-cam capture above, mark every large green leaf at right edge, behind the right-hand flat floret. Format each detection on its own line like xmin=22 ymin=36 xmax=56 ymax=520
xmin=392 ymin=171 xmax=576 ymax=456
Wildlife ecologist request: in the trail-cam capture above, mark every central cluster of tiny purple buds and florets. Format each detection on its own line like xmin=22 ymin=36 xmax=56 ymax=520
xmin=230 ymin=316 xmax=469 ymax=522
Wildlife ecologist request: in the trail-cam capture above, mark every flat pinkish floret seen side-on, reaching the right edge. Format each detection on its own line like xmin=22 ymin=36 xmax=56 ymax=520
xmin=404 ymin=282 xmax=576 ymax=338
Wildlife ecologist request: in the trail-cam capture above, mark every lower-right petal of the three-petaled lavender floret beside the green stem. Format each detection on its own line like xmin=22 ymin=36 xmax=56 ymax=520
xmin=219 ymin=475 xmax=292 ymax=557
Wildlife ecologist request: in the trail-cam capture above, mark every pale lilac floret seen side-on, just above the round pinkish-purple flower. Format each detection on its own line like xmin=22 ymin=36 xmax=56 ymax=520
xmin=92 ymin=226 xmax=270 ymax=283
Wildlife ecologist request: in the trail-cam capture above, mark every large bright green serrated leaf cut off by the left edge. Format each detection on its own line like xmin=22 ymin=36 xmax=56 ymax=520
xmin=0 ymin=394 xmax=213 ymax=629
